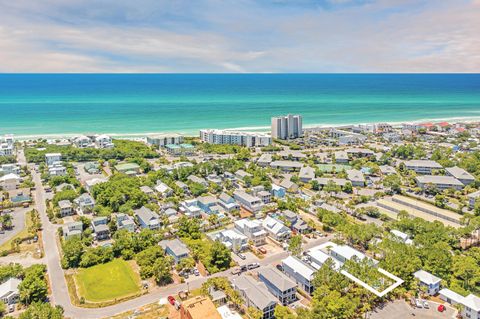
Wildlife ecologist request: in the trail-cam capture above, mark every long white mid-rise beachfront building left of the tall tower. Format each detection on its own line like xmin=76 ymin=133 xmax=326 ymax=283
xmin=200 ymin=129 xmax=272 ymax=147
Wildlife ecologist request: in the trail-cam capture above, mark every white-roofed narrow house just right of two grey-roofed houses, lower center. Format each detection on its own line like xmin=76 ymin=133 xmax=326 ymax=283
xmin=282 ymin=256 xmax=316 ymax=294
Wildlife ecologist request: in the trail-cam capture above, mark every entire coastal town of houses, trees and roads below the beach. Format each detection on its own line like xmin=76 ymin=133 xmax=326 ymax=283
xmin=0 ymin=114 xmax=480 ymax=319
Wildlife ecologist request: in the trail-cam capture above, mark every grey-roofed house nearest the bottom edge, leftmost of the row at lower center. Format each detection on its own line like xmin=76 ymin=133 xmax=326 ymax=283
xmin=231 ymin=274 xmax=277 ymax=319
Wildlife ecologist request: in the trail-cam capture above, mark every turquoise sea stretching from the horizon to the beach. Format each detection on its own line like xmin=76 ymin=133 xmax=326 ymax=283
xmin=0 ymin=74 xmax=480 ymax=136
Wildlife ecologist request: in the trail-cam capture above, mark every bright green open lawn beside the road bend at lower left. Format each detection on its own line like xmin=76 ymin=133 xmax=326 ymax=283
xmin=75 ymin=259 xmax=140 ymax=302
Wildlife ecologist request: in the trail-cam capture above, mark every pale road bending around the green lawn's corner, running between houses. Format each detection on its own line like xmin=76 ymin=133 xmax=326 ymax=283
xmin=33 ymin=164 xmax=328 ymax=319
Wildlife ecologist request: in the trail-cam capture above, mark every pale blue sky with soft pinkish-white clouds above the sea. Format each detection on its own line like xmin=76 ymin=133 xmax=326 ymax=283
xmin=0 ymin=0 xmax=480 ymax=73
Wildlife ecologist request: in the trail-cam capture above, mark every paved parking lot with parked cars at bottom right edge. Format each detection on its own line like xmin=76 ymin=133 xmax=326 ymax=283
xmin=368 ymin=300 xmax=455 ymax=319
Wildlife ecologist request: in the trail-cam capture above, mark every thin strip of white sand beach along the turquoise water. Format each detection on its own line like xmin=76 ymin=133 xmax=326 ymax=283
xmin=10 ymin=116 xmax=480 ymax=141
